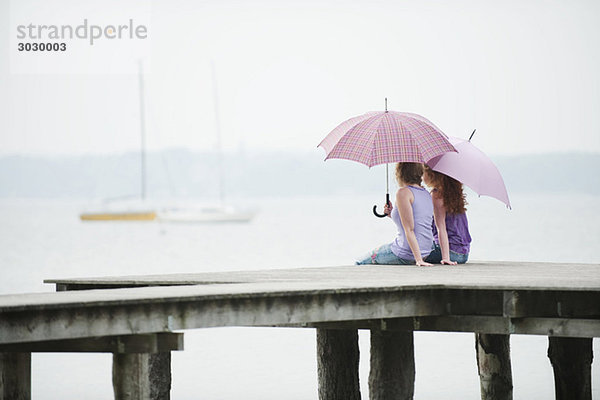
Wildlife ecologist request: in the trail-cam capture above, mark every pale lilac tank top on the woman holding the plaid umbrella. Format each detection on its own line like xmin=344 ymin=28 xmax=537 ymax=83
xmin=391 ymin=186 xmax=433 ymax=260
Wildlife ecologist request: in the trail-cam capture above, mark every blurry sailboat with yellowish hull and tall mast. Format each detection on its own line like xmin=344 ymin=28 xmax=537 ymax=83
xmin=79 ymin=60 xmax=157 ymax=221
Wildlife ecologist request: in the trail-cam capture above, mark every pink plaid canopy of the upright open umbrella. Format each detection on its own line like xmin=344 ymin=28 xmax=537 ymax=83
xmin=319 ymin=111 xmax=456 ymax=167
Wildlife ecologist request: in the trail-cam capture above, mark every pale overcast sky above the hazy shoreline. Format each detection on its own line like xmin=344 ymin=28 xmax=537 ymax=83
xmin=0 ymin=0 xmax=600 ymax=155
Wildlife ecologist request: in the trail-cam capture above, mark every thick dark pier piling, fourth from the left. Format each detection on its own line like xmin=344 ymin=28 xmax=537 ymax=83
xmin=369 ymin=330 xmax=415 ymax=400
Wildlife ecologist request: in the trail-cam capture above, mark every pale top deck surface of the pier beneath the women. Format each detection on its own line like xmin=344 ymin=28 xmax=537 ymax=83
xmin=44 ymin=261 xmax=600 ymax=290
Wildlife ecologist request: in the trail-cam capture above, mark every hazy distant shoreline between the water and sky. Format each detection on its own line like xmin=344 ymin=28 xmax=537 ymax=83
xmin=0 ymin=149 xmax=600 ymax=199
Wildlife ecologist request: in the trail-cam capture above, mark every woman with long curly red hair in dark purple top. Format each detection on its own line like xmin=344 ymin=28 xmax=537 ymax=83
xmin=423 ymin=166 xmax=471 ymax=265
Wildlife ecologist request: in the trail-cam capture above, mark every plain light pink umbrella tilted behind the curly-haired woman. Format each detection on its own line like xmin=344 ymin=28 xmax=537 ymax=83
xmin=427 ymin=131 xmax=510 ymax=208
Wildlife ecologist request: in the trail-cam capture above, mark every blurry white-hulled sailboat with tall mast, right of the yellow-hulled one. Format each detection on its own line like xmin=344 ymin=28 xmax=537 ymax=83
xmin=157 ymin=64 xmax=256 ymax=223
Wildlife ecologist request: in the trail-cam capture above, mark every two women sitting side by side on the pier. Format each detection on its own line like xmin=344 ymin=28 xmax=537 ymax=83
xmin=356 ymin=163 xmax=471 ymax=266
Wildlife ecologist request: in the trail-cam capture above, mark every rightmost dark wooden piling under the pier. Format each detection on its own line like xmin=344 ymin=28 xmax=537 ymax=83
xmin=548 ymin=336 xmax=593 ymax=400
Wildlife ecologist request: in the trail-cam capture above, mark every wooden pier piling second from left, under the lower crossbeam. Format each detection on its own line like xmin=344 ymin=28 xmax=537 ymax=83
xmin=113 ymin=352 xmax=171 ymax=400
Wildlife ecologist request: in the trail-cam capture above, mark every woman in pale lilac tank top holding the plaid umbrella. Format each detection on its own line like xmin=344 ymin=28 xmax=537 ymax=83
xmin=356 ymin=163 xmax=433 ymax=266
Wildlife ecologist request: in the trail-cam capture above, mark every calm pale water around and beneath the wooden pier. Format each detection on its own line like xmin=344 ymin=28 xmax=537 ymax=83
xmin=0 ymin=195 xmax=600 ymax=399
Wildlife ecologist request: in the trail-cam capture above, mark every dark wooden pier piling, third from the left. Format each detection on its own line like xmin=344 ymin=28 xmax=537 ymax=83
xmin=317 ymin=329 xmax=360 ymax=400
